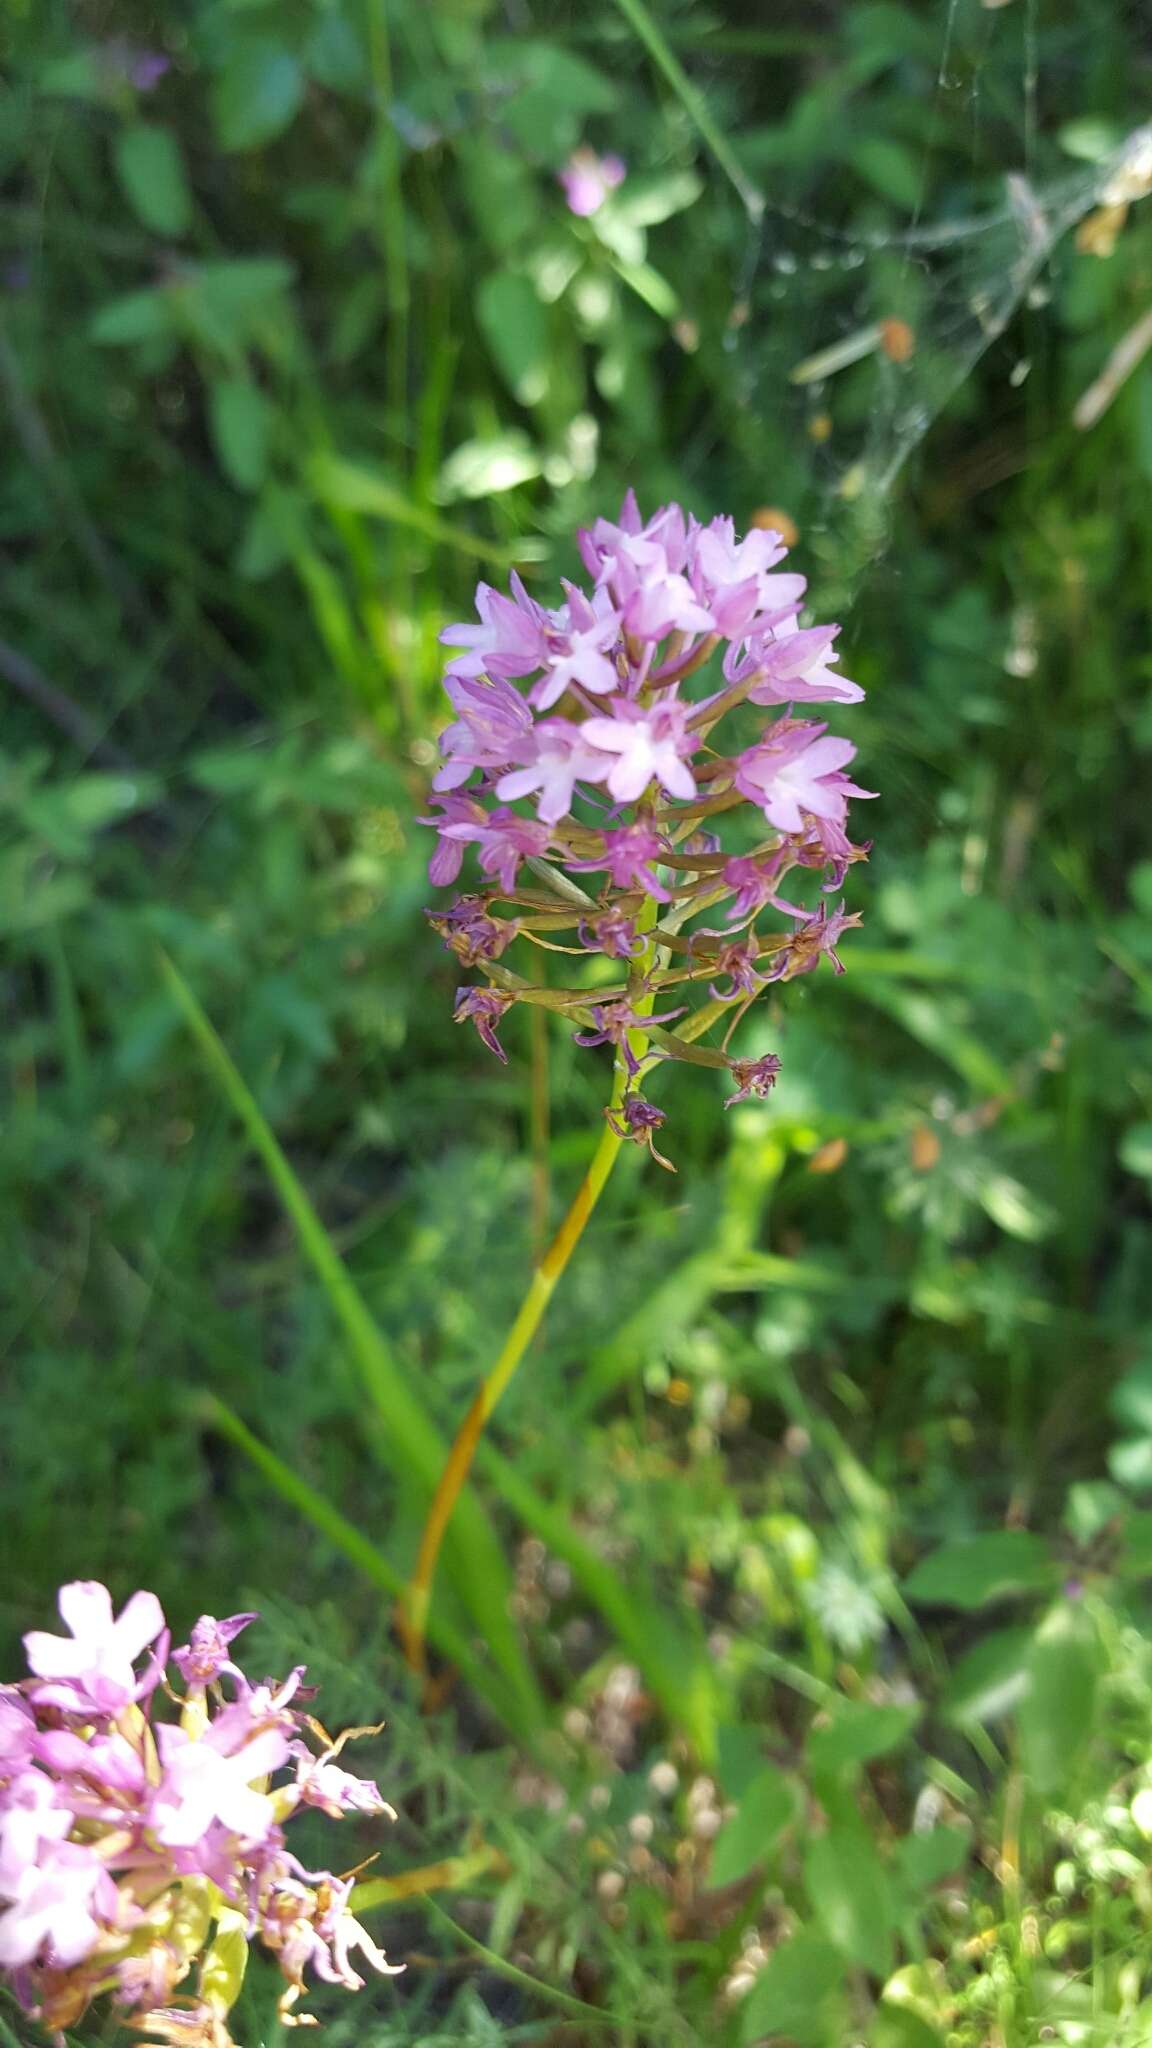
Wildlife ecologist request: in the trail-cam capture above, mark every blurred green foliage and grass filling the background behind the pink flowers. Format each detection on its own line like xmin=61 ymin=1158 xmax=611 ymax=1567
xmin=0 ymin=0 xmax=1152 ymax=2048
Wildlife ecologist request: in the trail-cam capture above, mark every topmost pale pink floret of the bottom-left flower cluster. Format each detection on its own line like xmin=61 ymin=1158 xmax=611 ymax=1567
xmin=25 ymin=1579 xmax=168 ymax=1714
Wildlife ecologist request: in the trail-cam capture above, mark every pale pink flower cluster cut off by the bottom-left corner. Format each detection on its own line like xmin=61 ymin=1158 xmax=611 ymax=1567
xmin=0 ymin=1581 xmax=392 ymax=2048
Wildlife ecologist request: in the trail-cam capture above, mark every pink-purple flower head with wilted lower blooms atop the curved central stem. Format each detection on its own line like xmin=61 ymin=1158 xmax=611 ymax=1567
xmin=428 ymin=492 xmax=873 ymax=1141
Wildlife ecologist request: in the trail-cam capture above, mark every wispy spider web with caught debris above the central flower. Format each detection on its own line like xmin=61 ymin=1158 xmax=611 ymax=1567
xmin=713 ymin=16 xmax=1152 ymax=582
